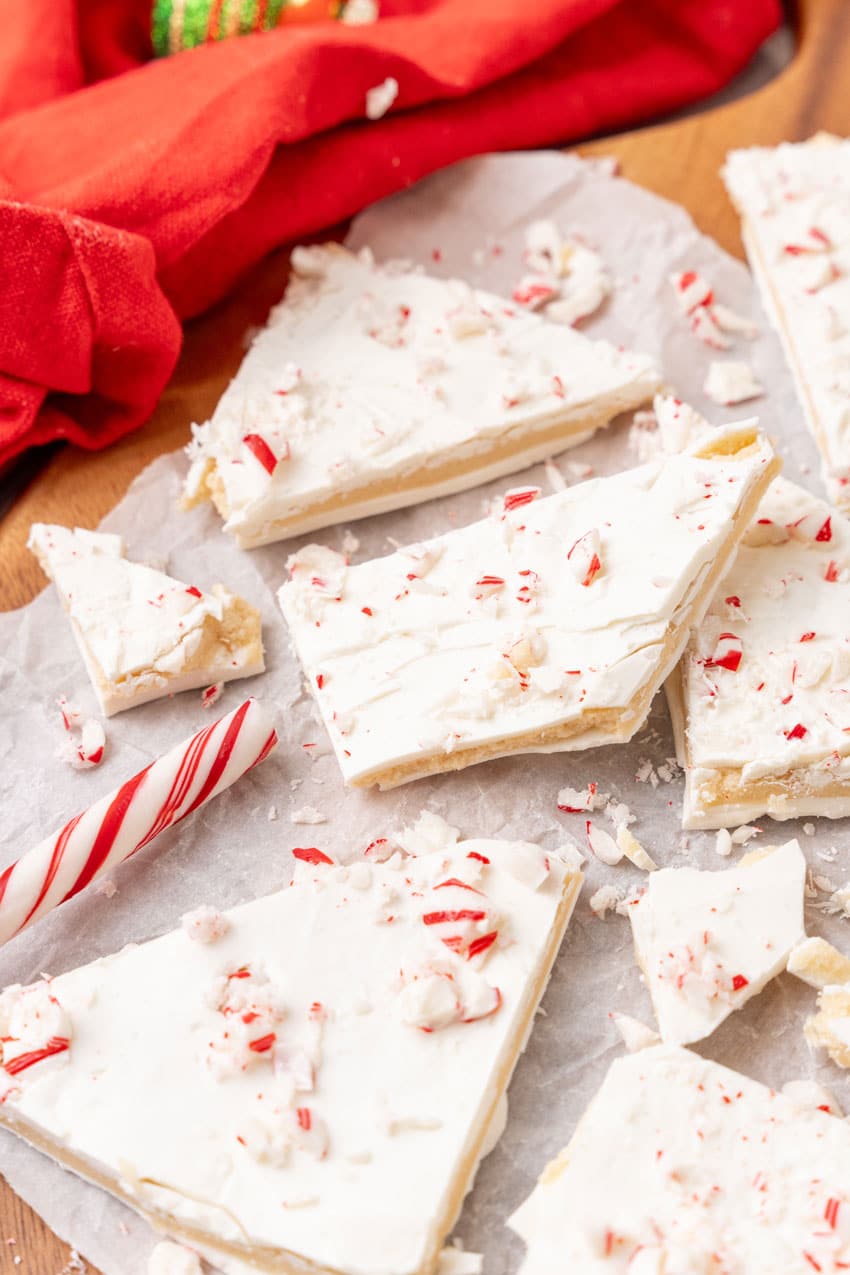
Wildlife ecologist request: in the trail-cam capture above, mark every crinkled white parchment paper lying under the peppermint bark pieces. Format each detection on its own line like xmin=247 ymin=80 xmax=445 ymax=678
xmin=0 ymin=153 xmax=850 ymax=1275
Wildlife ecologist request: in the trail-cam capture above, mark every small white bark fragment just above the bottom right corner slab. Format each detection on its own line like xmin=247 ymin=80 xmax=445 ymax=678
xmin=628 ymin=842 xmax=805 ymax=1044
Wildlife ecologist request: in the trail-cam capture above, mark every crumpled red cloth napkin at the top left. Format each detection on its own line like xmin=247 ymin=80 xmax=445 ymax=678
xmin=0 ymin=0 xmax=780 ymax=463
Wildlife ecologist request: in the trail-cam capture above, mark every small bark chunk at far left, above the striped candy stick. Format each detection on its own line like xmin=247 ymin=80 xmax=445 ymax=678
xmin=28 ymin=523 xmax=265 ymax=717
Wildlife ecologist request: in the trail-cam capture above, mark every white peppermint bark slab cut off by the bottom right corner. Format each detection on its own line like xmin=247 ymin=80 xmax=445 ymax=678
xmin=508 ymin=1044 xmax=850 ymax=1275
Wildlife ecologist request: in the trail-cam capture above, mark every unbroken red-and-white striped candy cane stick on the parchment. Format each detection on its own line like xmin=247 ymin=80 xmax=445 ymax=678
xmin=0 ymin=700 xmax=278 ymax=944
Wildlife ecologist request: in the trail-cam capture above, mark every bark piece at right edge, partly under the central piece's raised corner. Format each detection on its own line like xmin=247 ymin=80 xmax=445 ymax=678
xmin=666 ymin=478 xmax=850 ymax=829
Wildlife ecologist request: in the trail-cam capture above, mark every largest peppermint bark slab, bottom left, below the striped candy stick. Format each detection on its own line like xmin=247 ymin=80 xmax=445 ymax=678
xmin=0 ymin=819 xmax=581 ymax=1275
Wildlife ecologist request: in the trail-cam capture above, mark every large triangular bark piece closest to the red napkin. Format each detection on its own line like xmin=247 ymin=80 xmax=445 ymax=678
xmin=185 ymin=244 xmax=660 ymax=548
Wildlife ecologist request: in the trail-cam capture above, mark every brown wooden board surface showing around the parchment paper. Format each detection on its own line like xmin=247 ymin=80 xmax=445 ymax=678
xmin=0 ymin=0 xmax=850 ymax=1275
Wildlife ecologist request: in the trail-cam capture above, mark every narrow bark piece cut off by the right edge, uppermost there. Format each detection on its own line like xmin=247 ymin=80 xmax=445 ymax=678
xmin=724 ymin=134 xmax=850 ymax=507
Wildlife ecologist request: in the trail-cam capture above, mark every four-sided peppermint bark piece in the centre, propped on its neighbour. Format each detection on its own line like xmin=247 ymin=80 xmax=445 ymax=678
xmin=279 ymin=422 xmax=779 ymax=788
